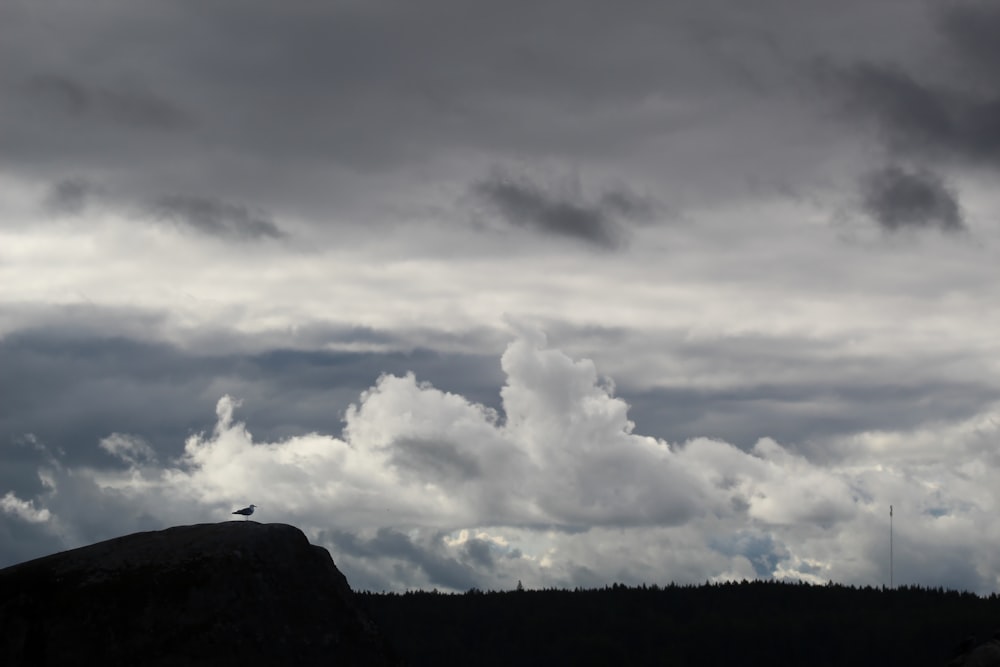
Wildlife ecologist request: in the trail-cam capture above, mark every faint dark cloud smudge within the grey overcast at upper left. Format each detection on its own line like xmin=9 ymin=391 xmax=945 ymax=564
xmin=22 ymin=74 xmax=190 ymax=130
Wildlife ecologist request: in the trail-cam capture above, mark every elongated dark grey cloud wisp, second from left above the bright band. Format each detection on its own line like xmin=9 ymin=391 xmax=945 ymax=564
xmin=150 ymin=195 xmax=287 ymax=240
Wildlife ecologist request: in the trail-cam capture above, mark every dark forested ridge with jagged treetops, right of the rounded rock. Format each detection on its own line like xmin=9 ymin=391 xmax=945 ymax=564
xmin=358 ymin=581 xmax=1000 ymax=667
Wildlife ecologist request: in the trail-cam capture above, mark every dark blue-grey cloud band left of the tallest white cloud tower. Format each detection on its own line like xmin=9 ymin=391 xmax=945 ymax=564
xmin=0 ymin=318 xmax=502 ymax=470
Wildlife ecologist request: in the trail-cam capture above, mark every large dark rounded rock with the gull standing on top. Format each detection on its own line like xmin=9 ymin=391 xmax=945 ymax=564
xmin=0 ymin=521 xmax=394 ymax=667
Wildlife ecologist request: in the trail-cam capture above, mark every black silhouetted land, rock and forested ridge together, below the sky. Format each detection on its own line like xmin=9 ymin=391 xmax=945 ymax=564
xmin=0 ymin=521 xmax=1000 ymax=667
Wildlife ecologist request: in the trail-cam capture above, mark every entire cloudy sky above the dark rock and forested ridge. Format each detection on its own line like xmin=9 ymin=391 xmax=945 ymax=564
xmin=0 ymin=0 xmax=1000 ymax=592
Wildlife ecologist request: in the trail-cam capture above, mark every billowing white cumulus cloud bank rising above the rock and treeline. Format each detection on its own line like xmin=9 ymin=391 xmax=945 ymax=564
xmin=9 ymin=335 xmax=1000 ymax=591
